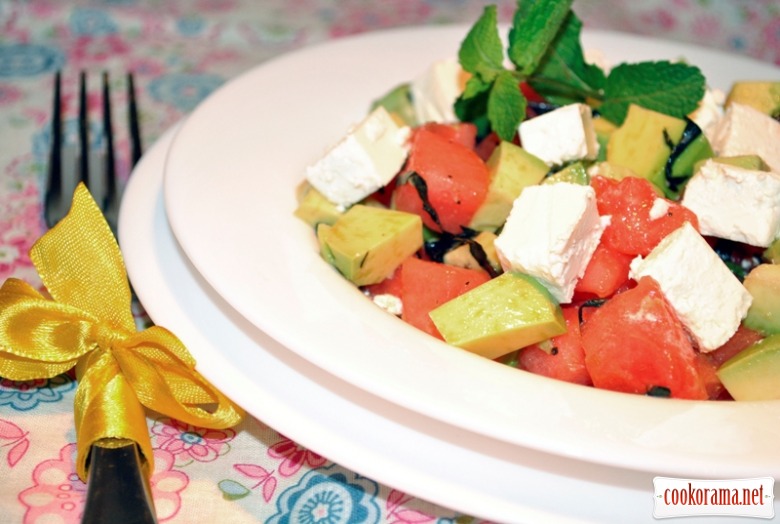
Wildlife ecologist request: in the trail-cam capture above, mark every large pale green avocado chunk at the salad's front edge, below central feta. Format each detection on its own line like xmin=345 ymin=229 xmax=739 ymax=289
xmin=430 ymin=272 xmax=566 ymax=359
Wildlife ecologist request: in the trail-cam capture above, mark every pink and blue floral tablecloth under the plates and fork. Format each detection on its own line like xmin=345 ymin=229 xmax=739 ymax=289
xmin=0 ymin=0 xmax=780 ymax=523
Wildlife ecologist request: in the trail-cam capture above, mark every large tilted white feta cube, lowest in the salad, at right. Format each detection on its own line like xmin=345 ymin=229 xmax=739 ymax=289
xmin=629 ymin=222 xmax=752 ymax=352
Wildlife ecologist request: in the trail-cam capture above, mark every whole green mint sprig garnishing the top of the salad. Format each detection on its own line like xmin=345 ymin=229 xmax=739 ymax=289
xmin=455 ymin=0 xmax=705 ymax=140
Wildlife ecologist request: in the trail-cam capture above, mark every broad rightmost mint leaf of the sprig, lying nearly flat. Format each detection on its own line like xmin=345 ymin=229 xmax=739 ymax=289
xmin=598 ymin=61 xmax=706 ymax=125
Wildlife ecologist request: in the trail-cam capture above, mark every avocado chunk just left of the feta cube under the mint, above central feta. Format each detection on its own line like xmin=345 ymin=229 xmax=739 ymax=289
xmin=469 ymin=141 xmax=549 ymax=231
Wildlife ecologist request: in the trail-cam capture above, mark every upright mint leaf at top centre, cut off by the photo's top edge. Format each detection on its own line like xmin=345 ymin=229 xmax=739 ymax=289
xmin=508 ymin=0 xmax=573 ymax=76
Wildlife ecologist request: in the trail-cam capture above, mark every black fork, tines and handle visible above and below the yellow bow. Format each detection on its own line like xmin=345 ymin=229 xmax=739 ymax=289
xmin=44 ymin=72 xmax=157 ymax=524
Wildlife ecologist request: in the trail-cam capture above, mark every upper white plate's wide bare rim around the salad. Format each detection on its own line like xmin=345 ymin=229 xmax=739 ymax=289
xmin=164 ymin=27 xmax=780 ymax=477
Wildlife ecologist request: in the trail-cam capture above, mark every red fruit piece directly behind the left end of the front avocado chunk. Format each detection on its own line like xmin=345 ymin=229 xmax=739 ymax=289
xmin=400 ymin=257 xmax=490 ymax=339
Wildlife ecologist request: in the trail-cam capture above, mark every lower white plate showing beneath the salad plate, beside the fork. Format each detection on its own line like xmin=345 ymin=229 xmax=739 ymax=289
xmin=119 ymin=124 xmax=684 ymax=523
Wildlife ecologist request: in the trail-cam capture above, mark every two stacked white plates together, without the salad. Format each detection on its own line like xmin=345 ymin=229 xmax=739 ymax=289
xmin=119 ymin=27 xmax=780 ymax=522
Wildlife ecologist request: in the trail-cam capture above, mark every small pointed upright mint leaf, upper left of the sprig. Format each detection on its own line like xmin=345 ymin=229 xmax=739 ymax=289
xmin=458 ymin=5 xmax=504 ymax=82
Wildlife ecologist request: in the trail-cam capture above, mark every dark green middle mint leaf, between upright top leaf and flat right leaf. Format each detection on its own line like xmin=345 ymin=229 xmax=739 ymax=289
xmin=528 ymin=12 xmax=606 ymax=105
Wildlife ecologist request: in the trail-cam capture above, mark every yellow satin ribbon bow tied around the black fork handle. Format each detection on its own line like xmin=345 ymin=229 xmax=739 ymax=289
xmin=0 ymin=184 xmax=243 ymax=480
